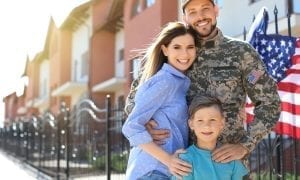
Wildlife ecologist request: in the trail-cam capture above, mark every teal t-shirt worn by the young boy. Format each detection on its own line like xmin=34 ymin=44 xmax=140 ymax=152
xmin=172 ymin=145 xmax=248 ymax=180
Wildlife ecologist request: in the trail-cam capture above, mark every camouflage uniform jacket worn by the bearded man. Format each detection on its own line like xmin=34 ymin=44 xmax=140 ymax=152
xmin=125 ymin=30 xmax=280 ymax=151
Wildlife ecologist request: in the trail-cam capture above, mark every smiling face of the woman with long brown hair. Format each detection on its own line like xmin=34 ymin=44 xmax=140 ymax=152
xmin=162 ymin=34 xmax=196 ymax=72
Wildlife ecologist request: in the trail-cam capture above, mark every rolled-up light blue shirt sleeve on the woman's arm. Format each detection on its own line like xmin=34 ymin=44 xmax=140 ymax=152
xmin=122 ymin=78 xmax=173 ymax=146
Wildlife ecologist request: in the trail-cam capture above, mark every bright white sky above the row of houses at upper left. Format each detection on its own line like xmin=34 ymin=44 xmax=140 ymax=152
xmin=0 ymin=0 xmax=87 ymax=122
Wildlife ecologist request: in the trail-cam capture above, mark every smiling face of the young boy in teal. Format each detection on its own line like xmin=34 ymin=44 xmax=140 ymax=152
xmin=189 ymin=106 xmax=225 ymax=145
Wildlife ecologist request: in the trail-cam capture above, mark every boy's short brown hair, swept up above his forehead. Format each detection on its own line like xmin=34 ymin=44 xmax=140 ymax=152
xmin=189 ymin=95 xmax=223 ymax=117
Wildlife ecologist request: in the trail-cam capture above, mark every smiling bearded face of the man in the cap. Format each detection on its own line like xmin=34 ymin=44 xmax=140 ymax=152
xmin=184 ymin=0 xmax=218 ymax=38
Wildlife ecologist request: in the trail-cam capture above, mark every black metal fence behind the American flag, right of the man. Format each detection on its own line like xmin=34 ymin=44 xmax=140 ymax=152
xmin=244 ymin=4 xmax=300 ymax=180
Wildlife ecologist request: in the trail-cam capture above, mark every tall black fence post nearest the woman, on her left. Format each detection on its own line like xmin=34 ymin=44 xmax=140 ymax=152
xmin=105 ymin=95 xmax=111 ymax=180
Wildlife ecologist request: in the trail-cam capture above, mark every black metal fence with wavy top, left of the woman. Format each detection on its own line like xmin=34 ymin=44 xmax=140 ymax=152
xmin=0 ymin=96 xmax=129 ymax=179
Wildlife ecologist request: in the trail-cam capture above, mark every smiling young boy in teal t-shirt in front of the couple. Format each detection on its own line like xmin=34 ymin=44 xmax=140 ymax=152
xmin=173 ymin=96 xmax=248 ymax=180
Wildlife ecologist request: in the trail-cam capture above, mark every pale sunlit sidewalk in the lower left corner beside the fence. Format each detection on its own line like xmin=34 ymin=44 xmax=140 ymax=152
xmin=0 ymin=151 xmax=49 ymax=180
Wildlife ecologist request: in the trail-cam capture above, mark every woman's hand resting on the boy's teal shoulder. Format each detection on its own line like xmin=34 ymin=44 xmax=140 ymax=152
xmin=167 ymin=149 xmax=192 ymax=179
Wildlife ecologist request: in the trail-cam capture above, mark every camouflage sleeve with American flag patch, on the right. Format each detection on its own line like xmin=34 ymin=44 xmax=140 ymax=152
xmin=241 ymin=45 xmax=280 ymax=152
